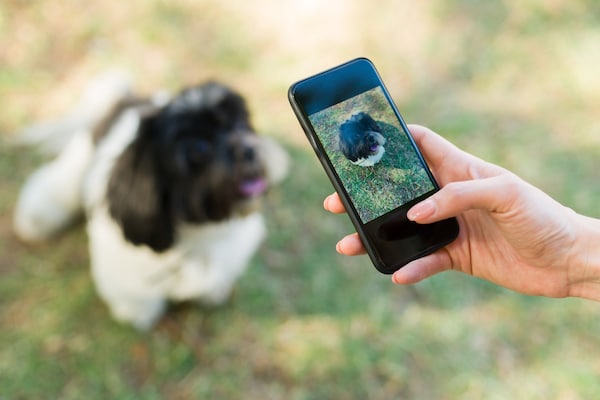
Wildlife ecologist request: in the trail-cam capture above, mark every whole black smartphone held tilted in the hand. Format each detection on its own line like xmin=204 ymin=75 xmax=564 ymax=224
xmin=288 ymin=58 xmax=458 ymax=274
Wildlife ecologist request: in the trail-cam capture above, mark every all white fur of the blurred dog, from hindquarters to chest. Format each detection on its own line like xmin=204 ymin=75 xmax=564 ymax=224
xmin=14 ymin=82 xmax=287 ymax=329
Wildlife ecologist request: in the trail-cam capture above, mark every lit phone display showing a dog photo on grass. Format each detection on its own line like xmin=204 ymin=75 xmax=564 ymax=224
xmin=308 ymin=86 xmax=435 ymax=224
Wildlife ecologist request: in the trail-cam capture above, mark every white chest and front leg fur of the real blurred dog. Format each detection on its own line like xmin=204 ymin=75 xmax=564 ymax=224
xmin=87 ymin=207 xmax=266 ymax=329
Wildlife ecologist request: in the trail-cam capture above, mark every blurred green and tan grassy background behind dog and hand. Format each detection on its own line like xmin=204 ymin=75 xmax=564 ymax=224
xmin=0 ymin=0 xmax=600 ymax=399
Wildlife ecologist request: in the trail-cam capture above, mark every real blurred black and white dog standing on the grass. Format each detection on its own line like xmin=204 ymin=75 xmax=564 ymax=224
xmin=14 ymin=75 xmax=288 ymax=329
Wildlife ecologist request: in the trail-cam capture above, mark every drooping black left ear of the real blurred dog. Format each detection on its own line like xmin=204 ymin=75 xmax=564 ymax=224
xmin=106 ymin=116 xmax=175 ymax=252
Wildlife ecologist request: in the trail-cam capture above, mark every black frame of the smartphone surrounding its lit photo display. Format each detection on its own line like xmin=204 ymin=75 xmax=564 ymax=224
xmin=288 ymin=57 xmax=458 ymax=274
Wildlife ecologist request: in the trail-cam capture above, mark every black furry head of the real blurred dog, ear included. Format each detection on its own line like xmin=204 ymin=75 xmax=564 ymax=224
xmin=107 ymin=83 xmax=283 ymax=251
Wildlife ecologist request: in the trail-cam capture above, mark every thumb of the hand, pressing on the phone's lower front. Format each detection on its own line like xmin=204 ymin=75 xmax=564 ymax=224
xmin=407 ymin=174 xmax=521 ymax=224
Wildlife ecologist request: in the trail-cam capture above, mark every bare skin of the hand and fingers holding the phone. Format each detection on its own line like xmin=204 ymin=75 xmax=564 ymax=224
xmin=324 ymin=125 xmax=600 ymax=301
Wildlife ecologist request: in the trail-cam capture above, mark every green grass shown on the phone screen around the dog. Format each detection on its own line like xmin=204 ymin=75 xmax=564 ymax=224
xmin=310 ymin=89 xmax=434 ymax=223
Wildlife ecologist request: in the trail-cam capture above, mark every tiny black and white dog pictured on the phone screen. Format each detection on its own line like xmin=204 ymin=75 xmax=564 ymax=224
xmin=338 ymin=112 xmax=386 ymax=167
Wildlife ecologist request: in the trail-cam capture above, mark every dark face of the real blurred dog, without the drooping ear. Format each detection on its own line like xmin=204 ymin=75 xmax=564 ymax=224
xmin=152 ymin=84 xmax=267 ymax=223
